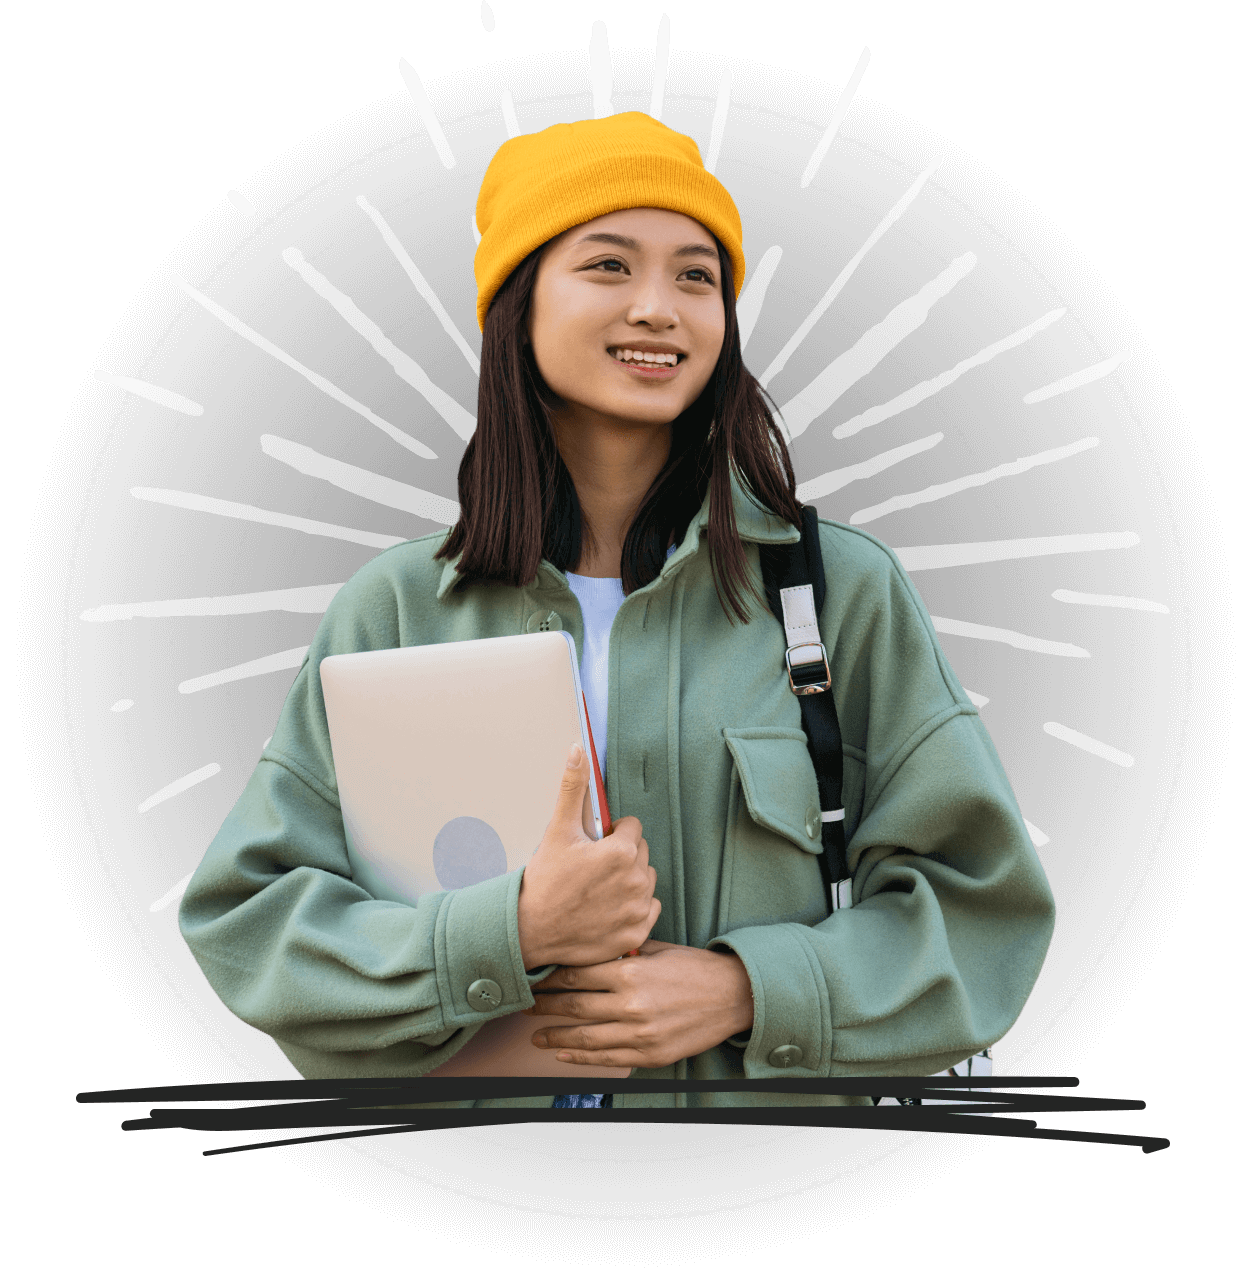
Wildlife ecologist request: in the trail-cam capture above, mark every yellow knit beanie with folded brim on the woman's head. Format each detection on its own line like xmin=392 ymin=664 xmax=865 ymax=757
xmin=474 ymin=112 xmax=747 ymax=333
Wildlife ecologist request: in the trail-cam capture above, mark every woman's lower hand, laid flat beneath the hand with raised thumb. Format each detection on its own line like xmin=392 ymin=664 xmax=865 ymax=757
xmin=529 ymin=940 xmax=754 ymax=1068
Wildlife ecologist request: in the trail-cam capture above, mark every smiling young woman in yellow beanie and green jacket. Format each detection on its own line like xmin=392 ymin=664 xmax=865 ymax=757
xmin=178 ymin=112 xmax=1056 ymax=1108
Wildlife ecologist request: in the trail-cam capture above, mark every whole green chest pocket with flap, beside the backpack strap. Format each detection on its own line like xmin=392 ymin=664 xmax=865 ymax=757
xmin=718 ymin=727 xmax=827 ymax=933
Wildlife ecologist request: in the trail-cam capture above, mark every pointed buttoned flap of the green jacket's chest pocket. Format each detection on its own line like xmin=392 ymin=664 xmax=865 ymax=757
xmin=723 ymin=726 xmax=821 ymax=855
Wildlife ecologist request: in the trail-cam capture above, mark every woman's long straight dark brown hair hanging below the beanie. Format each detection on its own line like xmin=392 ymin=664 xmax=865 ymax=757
xmin=436 ymin=241 xmax=802 ymax=623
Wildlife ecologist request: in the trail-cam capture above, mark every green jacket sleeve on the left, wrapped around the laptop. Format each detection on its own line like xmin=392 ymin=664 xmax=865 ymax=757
xmin=178 ymin=566 xmax=554 ymax=1078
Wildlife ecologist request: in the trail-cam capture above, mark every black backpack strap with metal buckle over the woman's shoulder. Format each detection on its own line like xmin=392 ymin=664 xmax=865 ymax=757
xmin=760 ymin=505 xmax=848 ymax=913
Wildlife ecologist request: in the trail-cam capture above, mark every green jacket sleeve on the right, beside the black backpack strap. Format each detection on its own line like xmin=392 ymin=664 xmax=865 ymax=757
xmin=709 ymin=530 xmax=1056 ymax=1077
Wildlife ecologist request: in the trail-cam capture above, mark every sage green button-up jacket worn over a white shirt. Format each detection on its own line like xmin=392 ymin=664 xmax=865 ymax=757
xmin=178 ymin=466 xmax=1056 ymax=1108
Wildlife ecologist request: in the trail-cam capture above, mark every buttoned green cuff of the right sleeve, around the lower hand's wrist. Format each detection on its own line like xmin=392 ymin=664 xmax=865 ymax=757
xmin=706 ymin=922 xmax=832 ymax=1078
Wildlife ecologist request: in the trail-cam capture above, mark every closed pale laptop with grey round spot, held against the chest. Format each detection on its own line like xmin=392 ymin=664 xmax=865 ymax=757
xmin=319 ymin=632 xmax=630 ymax=1078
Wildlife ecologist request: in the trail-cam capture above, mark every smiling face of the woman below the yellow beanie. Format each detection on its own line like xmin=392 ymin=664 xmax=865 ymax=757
xmin=527 ymin=209 xmax=725 ymax=428
